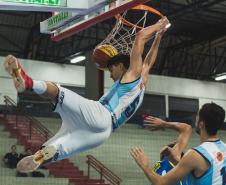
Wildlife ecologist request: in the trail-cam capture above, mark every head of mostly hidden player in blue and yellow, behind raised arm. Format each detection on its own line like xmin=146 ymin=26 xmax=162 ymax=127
xmin=160 ymin=142 xmax=184 ymax=161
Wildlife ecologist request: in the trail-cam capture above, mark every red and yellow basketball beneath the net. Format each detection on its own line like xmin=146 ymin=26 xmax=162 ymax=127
xmin=93 ymin=44 xmax=118 ymax=70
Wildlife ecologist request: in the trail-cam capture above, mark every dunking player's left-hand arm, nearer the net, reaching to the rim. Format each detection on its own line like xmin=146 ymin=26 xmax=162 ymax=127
xmin=123 ymin=17 xmax=166 ymax=80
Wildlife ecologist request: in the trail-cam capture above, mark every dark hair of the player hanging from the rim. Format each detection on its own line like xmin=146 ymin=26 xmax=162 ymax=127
xmin=107 ymin=54 xmax=130 ymax=69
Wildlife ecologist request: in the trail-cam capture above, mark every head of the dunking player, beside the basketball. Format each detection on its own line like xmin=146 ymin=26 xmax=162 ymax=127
xmin=107 ymin=54 xmax=130 ymax=81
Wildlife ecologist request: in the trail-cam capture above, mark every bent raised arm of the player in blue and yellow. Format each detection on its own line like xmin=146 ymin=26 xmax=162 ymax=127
xmin=145 ymin=116 xmax=192 ymax=162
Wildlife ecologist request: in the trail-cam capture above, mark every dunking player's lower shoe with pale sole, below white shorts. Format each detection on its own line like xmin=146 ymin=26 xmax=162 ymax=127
xmin=17 ymin=146 xmax=56 ymax=173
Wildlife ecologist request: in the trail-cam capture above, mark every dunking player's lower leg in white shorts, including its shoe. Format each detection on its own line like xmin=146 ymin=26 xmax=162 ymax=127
xmin=17 ymin=118 xmax=112 ymax=173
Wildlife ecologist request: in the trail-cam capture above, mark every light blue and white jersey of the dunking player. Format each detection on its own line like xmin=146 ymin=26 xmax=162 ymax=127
xmin=99 ymin=77 xmax=145 ymax=129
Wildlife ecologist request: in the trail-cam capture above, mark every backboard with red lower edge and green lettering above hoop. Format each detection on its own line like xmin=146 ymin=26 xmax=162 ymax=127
xmin=40 ymin=0 xmax=148 ymax=41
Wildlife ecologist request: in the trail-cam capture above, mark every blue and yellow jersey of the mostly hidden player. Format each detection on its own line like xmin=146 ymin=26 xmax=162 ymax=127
xmin=154 ymin=157 xmax=190 ymax=185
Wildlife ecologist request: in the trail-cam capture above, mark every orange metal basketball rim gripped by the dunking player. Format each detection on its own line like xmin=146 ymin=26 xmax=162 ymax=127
xmin=115 ymin=5 xmax=164 ymax=29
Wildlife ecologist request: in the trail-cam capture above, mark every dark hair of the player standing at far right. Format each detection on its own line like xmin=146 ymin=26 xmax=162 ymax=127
xmin=199 ymin=102 xmax=225 ymax=136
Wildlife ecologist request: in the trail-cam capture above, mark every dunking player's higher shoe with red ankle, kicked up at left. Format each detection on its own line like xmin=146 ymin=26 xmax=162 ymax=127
xmin=4 ymin=55 xmax=33 ymax=92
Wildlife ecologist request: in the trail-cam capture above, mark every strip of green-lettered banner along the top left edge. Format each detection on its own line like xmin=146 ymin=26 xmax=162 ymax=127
xmin=0 ymin=0 xmax=62 ymax=6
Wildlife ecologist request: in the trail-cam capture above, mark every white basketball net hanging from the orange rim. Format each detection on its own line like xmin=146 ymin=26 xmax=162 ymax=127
xmin=98 ymin=11 xmax=148 ymax=55
